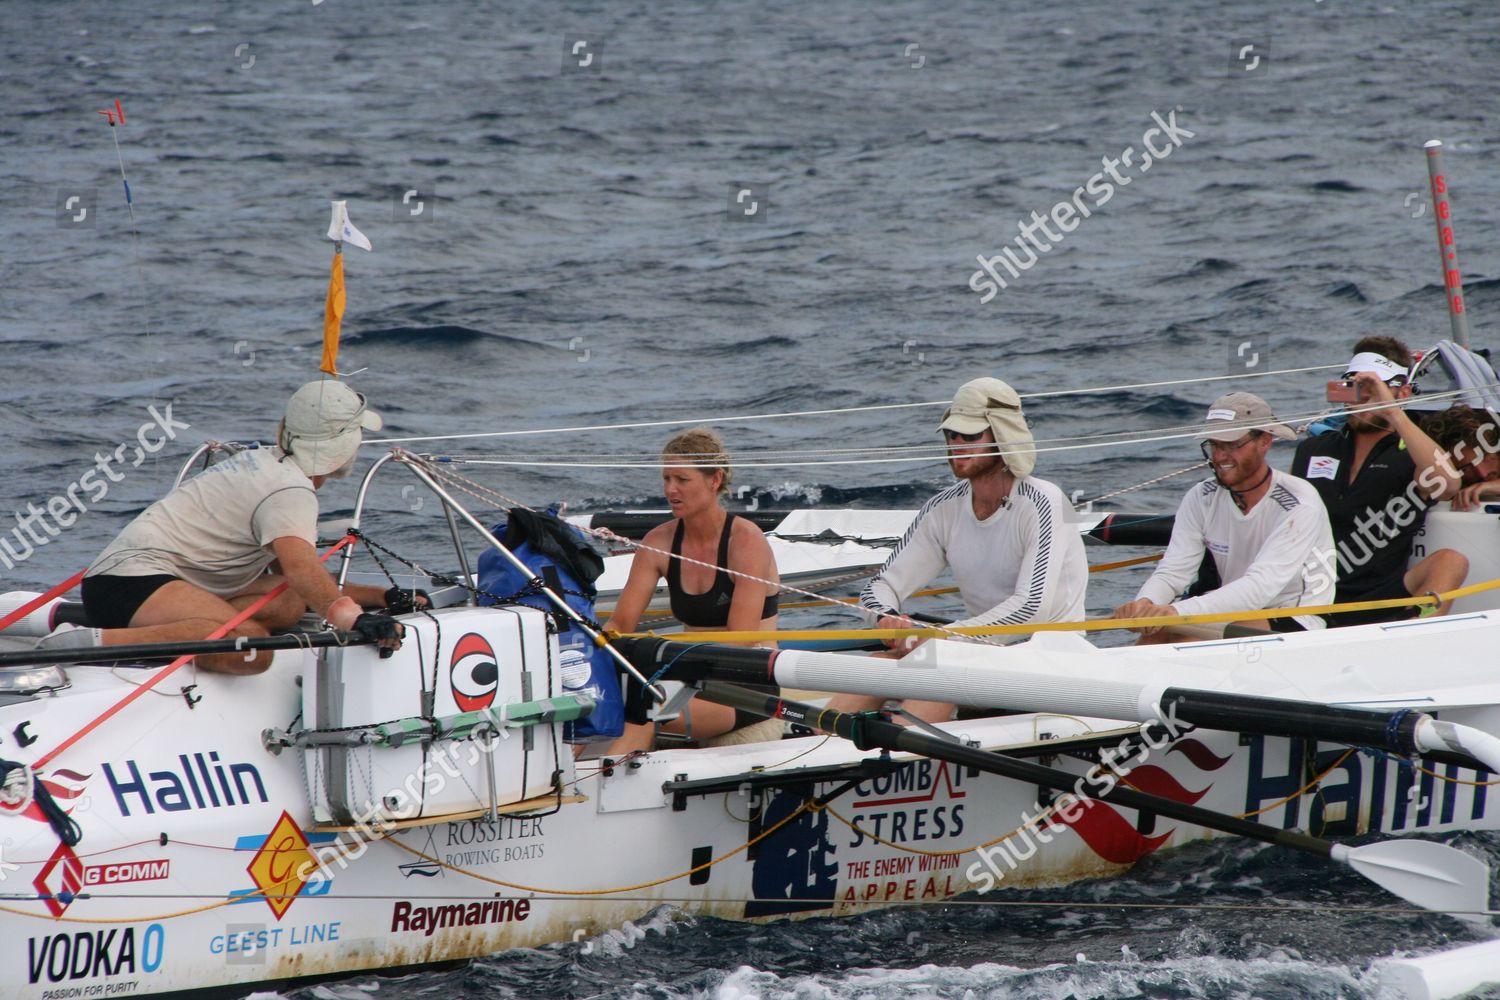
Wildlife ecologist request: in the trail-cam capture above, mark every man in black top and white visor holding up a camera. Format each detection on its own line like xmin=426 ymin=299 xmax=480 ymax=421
xmin=1292 ymin=337 xmax=1469 ymax=625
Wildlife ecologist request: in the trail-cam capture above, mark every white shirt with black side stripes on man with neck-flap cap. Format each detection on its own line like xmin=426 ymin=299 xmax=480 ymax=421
xmin=860 ymin=477 xmax=1089 ymax=625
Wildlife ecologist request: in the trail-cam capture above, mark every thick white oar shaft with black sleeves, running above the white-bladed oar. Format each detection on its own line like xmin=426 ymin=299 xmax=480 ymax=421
xmin=615 ymin=639 xmax=1500 ymax=772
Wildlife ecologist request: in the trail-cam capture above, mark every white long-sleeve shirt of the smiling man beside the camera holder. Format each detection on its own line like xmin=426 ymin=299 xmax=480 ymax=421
xmin=1136 ymin=469 xmax=1334 ymax=628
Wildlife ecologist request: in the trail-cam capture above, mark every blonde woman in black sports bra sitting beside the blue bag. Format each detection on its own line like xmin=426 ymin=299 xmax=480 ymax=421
xmin=605 ymin=427 xmax=780 ymax=754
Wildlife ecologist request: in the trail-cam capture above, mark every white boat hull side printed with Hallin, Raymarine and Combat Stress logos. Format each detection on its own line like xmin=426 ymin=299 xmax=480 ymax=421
xmin=0 ymin=609 xmax=1497 ymax=1000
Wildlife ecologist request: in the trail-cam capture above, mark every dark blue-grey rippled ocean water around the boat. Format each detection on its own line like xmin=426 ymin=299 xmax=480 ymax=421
xmin=0 ymin=0 xmax=1500 ymax=997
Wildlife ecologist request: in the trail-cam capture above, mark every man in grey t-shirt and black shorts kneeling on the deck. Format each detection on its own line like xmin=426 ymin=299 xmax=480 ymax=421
xmin=38 ymin=379 xmax=401 ymax=673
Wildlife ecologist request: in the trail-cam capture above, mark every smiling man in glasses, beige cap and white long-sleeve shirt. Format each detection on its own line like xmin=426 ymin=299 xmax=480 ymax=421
xmin=1115 ymin=393 xmax=1334 ymax=642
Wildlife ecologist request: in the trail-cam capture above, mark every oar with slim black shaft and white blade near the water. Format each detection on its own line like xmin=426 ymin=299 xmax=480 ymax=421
xmin=702 ymin=684 xmax=1490 ymax=921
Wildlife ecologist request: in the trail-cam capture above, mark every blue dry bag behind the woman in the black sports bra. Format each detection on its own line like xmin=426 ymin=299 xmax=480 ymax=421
xmin=479 ymin=507 xmax=626 ymax=744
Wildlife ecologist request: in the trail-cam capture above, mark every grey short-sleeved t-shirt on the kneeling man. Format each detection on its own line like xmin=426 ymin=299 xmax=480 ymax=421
xmin=89 ymin=448 xmax=318 ymax=598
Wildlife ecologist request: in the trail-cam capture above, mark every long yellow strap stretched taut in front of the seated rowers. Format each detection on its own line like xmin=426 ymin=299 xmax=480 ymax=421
xmin=618 ymin=580 xmax=1500 ymax=642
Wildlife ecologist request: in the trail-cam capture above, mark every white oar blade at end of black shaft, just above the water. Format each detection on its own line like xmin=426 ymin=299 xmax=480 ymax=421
xmin=1334 ymin=840 xmax=1490 ymax=922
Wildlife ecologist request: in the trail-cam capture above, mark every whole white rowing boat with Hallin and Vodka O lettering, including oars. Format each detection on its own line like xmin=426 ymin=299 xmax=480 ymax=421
xmin=0 ymin=456 xmax=1500 ymax=1000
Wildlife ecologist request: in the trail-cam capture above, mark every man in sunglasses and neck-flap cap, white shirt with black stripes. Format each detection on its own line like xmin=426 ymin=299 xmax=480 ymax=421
xmin=830 ymin=378 xmax=1089 ymax=723
